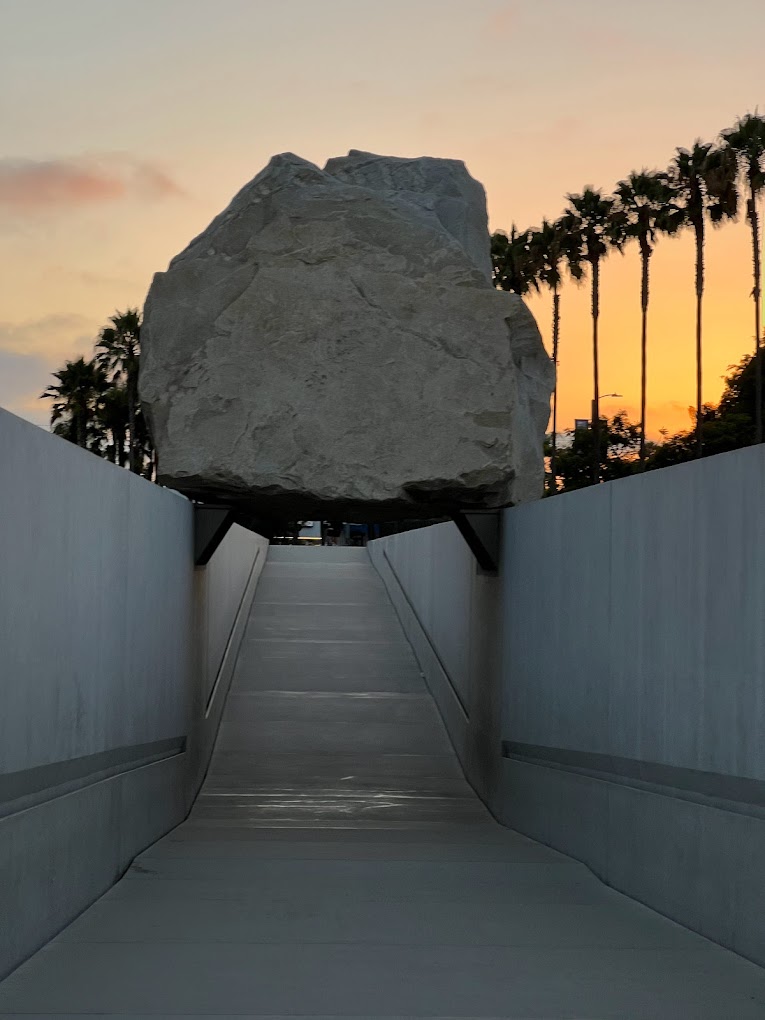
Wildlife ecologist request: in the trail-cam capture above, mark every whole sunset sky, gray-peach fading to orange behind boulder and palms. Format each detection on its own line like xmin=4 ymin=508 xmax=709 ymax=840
xmin=0 ymin=0 xmax=765 ymax=436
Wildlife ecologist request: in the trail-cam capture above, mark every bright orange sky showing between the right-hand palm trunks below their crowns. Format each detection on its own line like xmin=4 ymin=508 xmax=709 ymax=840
xmin=528 ymin=222 xmax=754 ymax=440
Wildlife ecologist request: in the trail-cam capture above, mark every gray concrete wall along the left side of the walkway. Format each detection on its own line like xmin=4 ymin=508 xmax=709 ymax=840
xmin=0 ymin=410 xmax=266 ymax=976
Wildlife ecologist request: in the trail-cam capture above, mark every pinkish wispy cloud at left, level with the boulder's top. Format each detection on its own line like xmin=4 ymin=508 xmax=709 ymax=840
xmin=0 ymin=154 xmax=183 ymax=214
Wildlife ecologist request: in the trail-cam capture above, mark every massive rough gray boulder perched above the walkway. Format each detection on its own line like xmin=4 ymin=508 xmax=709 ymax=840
xmin=140 ymin=152 xmax=553 ymax=520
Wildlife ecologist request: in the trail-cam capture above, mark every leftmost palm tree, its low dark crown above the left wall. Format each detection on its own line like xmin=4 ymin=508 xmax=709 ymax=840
xmin=40 ymin=358 xmax=109 ymax=450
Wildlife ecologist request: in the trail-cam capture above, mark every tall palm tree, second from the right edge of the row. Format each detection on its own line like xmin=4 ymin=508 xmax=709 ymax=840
xmin=667 ymin=141 xmax=738 ymax=457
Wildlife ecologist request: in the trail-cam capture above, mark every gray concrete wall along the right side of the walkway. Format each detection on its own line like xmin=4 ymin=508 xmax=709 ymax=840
xmin=371 ymin=447 xmax=765 ymax=964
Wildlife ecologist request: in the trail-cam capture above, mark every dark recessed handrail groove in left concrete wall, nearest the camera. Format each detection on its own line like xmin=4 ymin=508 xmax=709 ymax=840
xmin=0 ymin=736 xmax=186 ymax=815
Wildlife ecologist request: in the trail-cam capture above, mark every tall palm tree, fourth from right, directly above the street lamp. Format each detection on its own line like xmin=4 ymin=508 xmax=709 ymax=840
xmin=562 ymin=186 xmax=621 ymax=485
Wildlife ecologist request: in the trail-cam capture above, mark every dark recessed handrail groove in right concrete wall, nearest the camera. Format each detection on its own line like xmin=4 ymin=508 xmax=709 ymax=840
xmin=502 ymin=741 xmax=765 ymax=814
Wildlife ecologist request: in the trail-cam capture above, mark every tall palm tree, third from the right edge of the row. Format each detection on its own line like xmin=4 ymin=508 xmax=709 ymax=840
xmin=616 ymin=169 xmax=673 ymax=469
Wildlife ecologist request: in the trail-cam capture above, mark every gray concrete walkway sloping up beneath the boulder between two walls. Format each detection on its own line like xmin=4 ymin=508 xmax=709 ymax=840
xmin=0 ymin=549 xmax=765 ymax=1020
